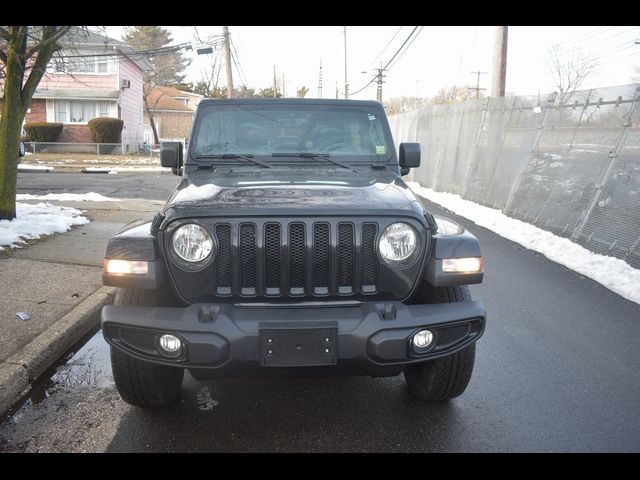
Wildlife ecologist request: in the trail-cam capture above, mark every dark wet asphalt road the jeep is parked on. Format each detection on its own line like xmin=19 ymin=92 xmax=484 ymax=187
xmin=0 ymin=176 xmax=640 ymax=452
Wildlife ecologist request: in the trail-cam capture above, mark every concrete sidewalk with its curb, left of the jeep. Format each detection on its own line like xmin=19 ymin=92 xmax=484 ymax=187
xmin=0 ymin=199 xmax=164 ymax=415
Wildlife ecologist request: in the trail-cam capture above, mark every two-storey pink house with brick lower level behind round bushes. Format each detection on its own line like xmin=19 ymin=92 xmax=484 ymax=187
xmin=25 ymin=32 xmax=152 ymax=151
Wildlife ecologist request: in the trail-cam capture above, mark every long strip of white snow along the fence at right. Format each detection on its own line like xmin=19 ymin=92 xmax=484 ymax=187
xmin=408 ymin=182 xmax=640 ymax=304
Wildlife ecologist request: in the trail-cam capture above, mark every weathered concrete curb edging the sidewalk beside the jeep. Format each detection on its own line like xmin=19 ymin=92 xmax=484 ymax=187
xmin=0 ymin=287 xmax=116 ymax=415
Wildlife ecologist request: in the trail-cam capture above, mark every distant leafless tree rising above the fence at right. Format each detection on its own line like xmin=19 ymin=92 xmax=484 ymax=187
xmin=548 ymin=45 xmax=598 ymax=104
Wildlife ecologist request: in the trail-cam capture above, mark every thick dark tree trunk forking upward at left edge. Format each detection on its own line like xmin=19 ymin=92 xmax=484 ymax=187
xmin=0 ymin=25 xmax=72 ymax=220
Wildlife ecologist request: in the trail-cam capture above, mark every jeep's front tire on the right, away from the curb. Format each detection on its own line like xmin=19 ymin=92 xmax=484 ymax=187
xmin=404 ymin=284 xmax=476 ymax=402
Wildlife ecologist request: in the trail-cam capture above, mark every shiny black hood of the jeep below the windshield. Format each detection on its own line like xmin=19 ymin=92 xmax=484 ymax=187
xmin=164 ymin=169 xmax=424 ymax=222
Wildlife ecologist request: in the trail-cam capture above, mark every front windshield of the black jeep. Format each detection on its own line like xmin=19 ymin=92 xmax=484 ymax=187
xmin=191 ymin=104 xmax=390 ymax=161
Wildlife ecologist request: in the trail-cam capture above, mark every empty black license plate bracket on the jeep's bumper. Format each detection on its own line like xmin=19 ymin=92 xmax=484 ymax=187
xmin=260 ymin=328 xmax=338 ymax=367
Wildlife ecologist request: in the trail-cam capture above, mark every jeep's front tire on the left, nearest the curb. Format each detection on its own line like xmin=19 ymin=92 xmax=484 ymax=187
xmin=111 ymin=288 xmax=184 ymax=408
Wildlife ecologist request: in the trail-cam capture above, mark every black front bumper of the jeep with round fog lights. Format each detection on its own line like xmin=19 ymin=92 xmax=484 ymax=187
xmin=102 ymin=302 xmax=486 ymax=376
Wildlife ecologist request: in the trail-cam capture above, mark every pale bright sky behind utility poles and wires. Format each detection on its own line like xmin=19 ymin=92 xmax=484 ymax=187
xmin=102 ymin=26 xmax=640 ymax=99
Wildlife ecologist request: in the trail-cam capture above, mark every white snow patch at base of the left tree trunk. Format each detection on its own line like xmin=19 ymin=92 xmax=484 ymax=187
xmin=0 ymin=203 xmax=89 ymax=250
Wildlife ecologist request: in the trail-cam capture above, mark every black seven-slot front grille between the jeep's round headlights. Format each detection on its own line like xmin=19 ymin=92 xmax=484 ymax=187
xmin=213 ymin=220 xmax=378 ymax=297
